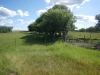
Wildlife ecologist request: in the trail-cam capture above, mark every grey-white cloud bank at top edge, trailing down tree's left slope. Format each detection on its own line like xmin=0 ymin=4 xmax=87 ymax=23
xmin=36 ymin=0 xmax=90 ymax=16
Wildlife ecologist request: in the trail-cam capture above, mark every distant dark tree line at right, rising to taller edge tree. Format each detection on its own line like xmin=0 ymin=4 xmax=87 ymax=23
xmin=78 ymin=14 xmax=100 ymax=32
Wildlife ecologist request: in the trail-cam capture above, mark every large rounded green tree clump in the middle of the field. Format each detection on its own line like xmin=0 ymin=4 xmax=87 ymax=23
xmin=27 ymin=4 xmax=76 ymax=41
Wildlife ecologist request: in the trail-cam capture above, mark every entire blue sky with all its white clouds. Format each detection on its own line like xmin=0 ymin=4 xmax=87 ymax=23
xmin=0 ymin=0 xmax=100 ymax=30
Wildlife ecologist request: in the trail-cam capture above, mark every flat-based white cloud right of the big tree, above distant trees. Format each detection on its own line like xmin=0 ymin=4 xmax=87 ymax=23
xmin=76 ymin=15 xmax=96 ymax=23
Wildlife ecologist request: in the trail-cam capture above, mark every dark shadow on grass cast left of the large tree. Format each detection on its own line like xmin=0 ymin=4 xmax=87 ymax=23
xmin=21 ymin=32 xmax=56 ymax=45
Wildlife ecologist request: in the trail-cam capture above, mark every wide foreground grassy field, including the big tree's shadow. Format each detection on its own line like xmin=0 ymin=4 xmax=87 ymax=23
xmin=0 ymin=31 xmax=100 ymax=75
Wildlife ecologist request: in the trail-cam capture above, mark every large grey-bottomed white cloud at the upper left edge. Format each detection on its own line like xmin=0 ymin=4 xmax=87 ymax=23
xmin=0 ymin=7 xmax=17 ymax=17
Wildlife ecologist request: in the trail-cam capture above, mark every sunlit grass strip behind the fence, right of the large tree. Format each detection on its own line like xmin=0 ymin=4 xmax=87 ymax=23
xmin=68 ymin=31 xmax=100 ymax=44
